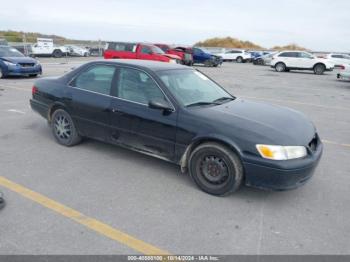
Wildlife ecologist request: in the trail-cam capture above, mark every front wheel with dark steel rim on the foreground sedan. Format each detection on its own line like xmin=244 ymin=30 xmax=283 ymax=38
xmin=188 ymin=142 xmax=243 ymax=196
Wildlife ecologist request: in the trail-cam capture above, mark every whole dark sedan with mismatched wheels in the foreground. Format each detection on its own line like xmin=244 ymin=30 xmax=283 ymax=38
xmin=30 ymin=60 xmax=322 ymax=195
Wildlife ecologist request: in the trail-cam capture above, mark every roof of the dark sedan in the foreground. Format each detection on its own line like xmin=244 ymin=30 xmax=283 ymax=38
xmin=89 ymin=59 xmax=191 ymax=71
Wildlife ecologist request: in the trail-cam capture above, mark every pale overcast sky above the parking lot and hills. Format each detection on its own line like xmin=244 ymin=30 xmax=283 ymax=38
xmin=0 ymin=0 xmax=350 ymax=51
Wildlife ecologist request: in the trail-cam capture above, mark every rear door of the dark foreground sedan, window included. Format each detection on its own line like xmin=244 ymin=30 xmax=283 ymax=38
xmin=67 ymin=64 xmax=116 ymax=140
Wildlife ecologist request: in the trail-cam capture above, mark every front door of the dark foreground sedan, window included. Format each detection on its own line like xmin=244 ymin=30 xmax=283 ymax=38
xmin=111 ymin=67 xmax=177 ymax=160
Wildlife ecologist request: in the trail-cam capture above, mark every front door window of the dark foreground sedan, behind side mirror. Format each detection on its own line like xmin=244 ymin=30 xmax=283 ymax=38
xmin=118 ymin=68 xmax=166 ymax=104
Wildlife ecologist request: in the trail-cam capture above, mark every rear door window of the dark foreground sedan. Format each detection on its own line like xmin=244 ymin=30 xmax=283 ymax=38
xmin=72 ymin=65 xmax=115 ymax=95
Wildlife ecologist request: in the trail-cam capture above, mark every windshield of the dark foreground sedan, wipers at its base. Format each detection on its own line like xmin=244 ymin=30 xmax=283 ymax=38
xmin=158 ymin=69 xmax=235 ymax=107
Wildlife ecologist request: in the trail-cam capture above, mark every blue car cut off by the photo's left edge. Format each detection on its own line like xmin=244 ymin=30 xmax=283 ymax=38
xmin=0 ymin=46 xmax=42 ymax=78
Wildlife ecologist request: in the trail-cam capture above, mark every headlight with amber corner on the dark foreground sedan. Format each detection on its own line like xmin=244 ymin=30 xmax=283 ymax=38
xmin=256 ymin=145 xmax=307 ymax=160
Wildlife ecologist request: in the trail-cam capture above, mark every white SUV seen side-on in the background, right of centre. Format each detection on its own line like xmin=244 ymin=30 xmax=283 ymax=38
xmin=271 ymin=51 xmax=334 ymax=75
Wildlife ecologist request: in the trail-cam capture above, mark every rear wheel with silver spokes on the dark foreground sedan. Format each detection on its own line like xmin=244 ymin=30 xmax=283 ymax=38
xmin=51 ymin=109 xmax=81 ymax=146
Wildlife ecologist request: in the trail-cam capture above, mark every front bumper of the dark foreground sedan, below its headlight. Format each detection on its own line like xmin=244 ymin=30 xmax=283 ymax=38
xmin=243 ymin=141 xmax=323 ymax=190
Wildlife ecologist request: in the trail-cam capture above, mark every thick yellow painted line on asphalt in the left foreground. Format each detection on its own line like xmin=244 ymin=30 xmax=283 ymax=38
xmin=0 ymin=176 xmax=169 ymax=255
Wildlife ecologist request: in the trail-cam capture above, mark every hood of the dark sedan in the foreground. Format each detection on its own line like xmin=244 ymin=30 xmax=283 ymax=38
xmin=197 ymin=99 xmax=316 ymax=145
